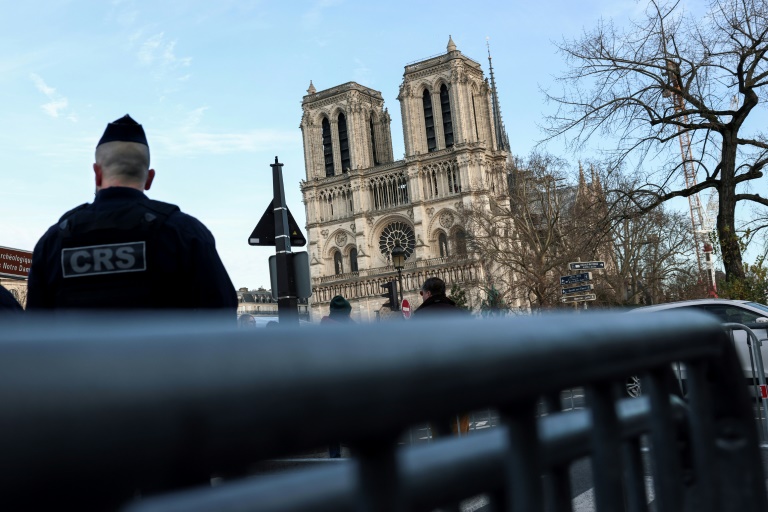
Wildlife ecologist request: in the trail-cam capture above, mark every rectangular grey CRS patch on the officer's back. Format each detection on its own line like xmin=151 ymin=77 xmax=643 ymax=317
xmin=61 ymin=242 xmax=147 ymax=277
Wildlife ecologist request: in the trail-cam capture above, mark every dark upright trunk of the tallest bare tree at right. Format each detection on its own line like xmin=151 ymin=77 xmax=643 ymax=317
xmin=720 ymin=132 xmax=744 ymax=282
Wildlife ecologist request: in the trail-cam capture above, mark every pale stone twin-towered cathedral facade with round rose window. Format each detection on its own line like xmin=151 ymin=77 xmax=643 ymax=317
xmin=301 ymin=37 xmax=509 ymax=321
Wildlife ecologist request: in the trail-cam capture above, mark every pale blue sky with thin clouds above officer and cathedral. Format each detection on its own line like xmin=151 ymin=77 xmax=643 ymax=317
xmin=0 ymin=0 xmax=748 ymax=288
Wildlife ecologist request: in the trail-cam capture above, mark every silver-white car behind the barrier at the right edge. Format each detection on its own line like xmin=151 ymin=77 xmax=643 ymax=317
xmin=626 ymin=299 xmax=768 ymax=396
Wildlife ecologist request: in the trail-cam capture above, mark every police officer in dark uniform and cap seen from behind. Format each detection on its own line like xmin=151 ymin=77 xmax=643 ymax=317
xmin=27 ymin=115 xmax=237 ymax=312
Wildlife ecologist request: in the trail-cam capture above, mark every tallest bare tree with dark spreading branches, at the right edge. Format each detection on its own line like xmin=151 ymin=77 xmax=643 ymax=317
xmin=547 ymin=0 xmax=768 ymax=281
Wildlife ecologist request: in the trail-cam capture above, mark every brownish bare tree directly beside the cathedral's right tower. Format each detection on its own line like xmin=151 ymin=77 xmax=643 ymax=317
xmin=460 ymin=154 xmax=604 ymax=310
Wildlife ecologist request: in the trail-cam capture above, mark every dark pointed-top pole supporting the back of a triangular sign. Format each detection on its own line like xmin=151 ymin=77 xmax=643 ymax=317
xmin=270 ymin=157 xmax=299 ymax=325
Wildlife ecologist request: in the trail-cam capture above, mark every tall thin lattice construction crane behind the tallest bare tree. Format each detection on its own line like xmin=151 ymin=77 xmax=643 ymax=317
xmin=663 ymin=59 xmax=716 ymax=297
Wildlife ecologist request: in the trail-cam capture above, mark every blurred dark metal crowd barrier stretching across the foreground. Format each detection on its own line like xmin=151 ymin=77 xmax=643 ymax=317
xmin=0 ymin=311 xmax=768 ymax=512
